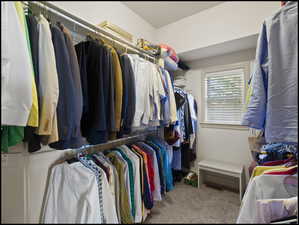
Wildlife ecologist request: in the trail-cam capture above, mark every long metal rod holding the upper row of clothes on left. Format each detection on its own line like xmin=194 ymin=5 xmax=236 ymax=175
xmin=23 ymin=1 xmax=156 ymax=61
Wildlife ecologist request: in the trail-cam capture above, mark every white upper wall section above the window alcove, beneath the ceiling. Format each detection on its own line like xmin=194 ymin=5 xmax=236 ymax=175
xmin=155 ymin=1 xmax=280 ymax=53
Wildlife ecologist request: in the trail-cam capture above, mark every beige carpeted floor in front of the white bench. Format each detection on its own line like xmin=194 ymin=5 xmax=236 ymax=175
xmin=144 ymin=183 xmax=240 ymax=224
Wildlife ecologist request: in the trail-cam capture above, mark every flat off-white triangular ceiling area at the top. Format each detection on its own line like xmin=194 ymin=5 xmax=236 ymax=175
xmin=121 ymin=1 xmax=223 ymax=28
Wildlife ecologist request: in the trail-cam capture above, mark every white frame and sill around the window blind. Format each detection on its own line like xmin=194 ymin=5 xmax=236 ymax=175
xmin=200 ymin=61 xmax=252 ymax=130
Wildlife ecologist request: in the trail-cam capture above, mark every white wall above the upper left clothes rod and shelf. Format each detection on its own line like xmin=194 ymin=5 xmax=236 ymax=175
xmin=51 ymin=1 xmax=155 ymax=43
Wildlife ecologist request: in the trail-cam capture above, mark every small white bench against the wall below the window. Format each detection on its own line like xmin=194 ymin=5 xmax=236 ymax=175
xmin=198 ymin=160 xmax=245 ymax=201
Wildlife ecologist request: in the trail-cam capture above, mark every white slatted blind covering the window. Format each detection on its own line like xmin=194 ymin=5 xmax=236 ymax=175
xmin=205 ymin=69 xmax=244 ymax=124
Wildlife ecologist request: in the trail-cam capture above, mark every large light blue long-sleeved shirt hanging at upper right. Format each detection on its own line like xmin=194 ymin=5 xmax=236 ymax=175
xmin=242 ymin=2 xmax=298 ymax=143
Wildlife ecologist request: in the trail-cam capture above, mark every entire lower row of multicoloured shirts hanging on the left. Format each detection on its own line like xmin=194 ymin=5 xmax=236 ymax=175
xmin=42 ymin=137 xmax=173 ymax=223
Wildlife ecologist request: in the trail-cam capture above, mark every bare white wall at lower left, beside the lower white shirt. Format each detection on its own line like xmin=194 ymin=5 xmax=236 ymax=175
xmin=1 ymin=143 xmax=72 ymax=223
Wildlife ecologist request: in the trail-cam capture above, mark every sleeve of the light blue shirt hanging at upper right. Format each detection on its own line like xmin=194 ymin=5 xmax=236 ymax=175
xmin=242 ymin=22 xmax=269 ymax=129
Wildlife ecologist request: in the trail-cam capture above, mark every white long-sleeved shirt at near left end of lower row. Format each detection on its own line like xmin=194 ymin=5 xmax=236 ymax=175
xmin=41 ymin=162 xmax=105 ymax=223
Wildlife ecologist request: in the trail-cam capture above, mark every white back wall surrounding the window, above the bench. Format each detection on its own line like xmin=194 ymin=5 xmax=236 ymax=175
xmin=185 ymin=49 xmax=255 ymax=182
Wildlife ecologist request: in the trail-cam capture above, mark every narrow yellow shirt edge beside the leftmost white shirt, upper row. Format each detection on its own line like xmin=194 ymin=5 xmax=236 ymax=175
xmin=15 ymin=2 xmax=38 ymax=127
